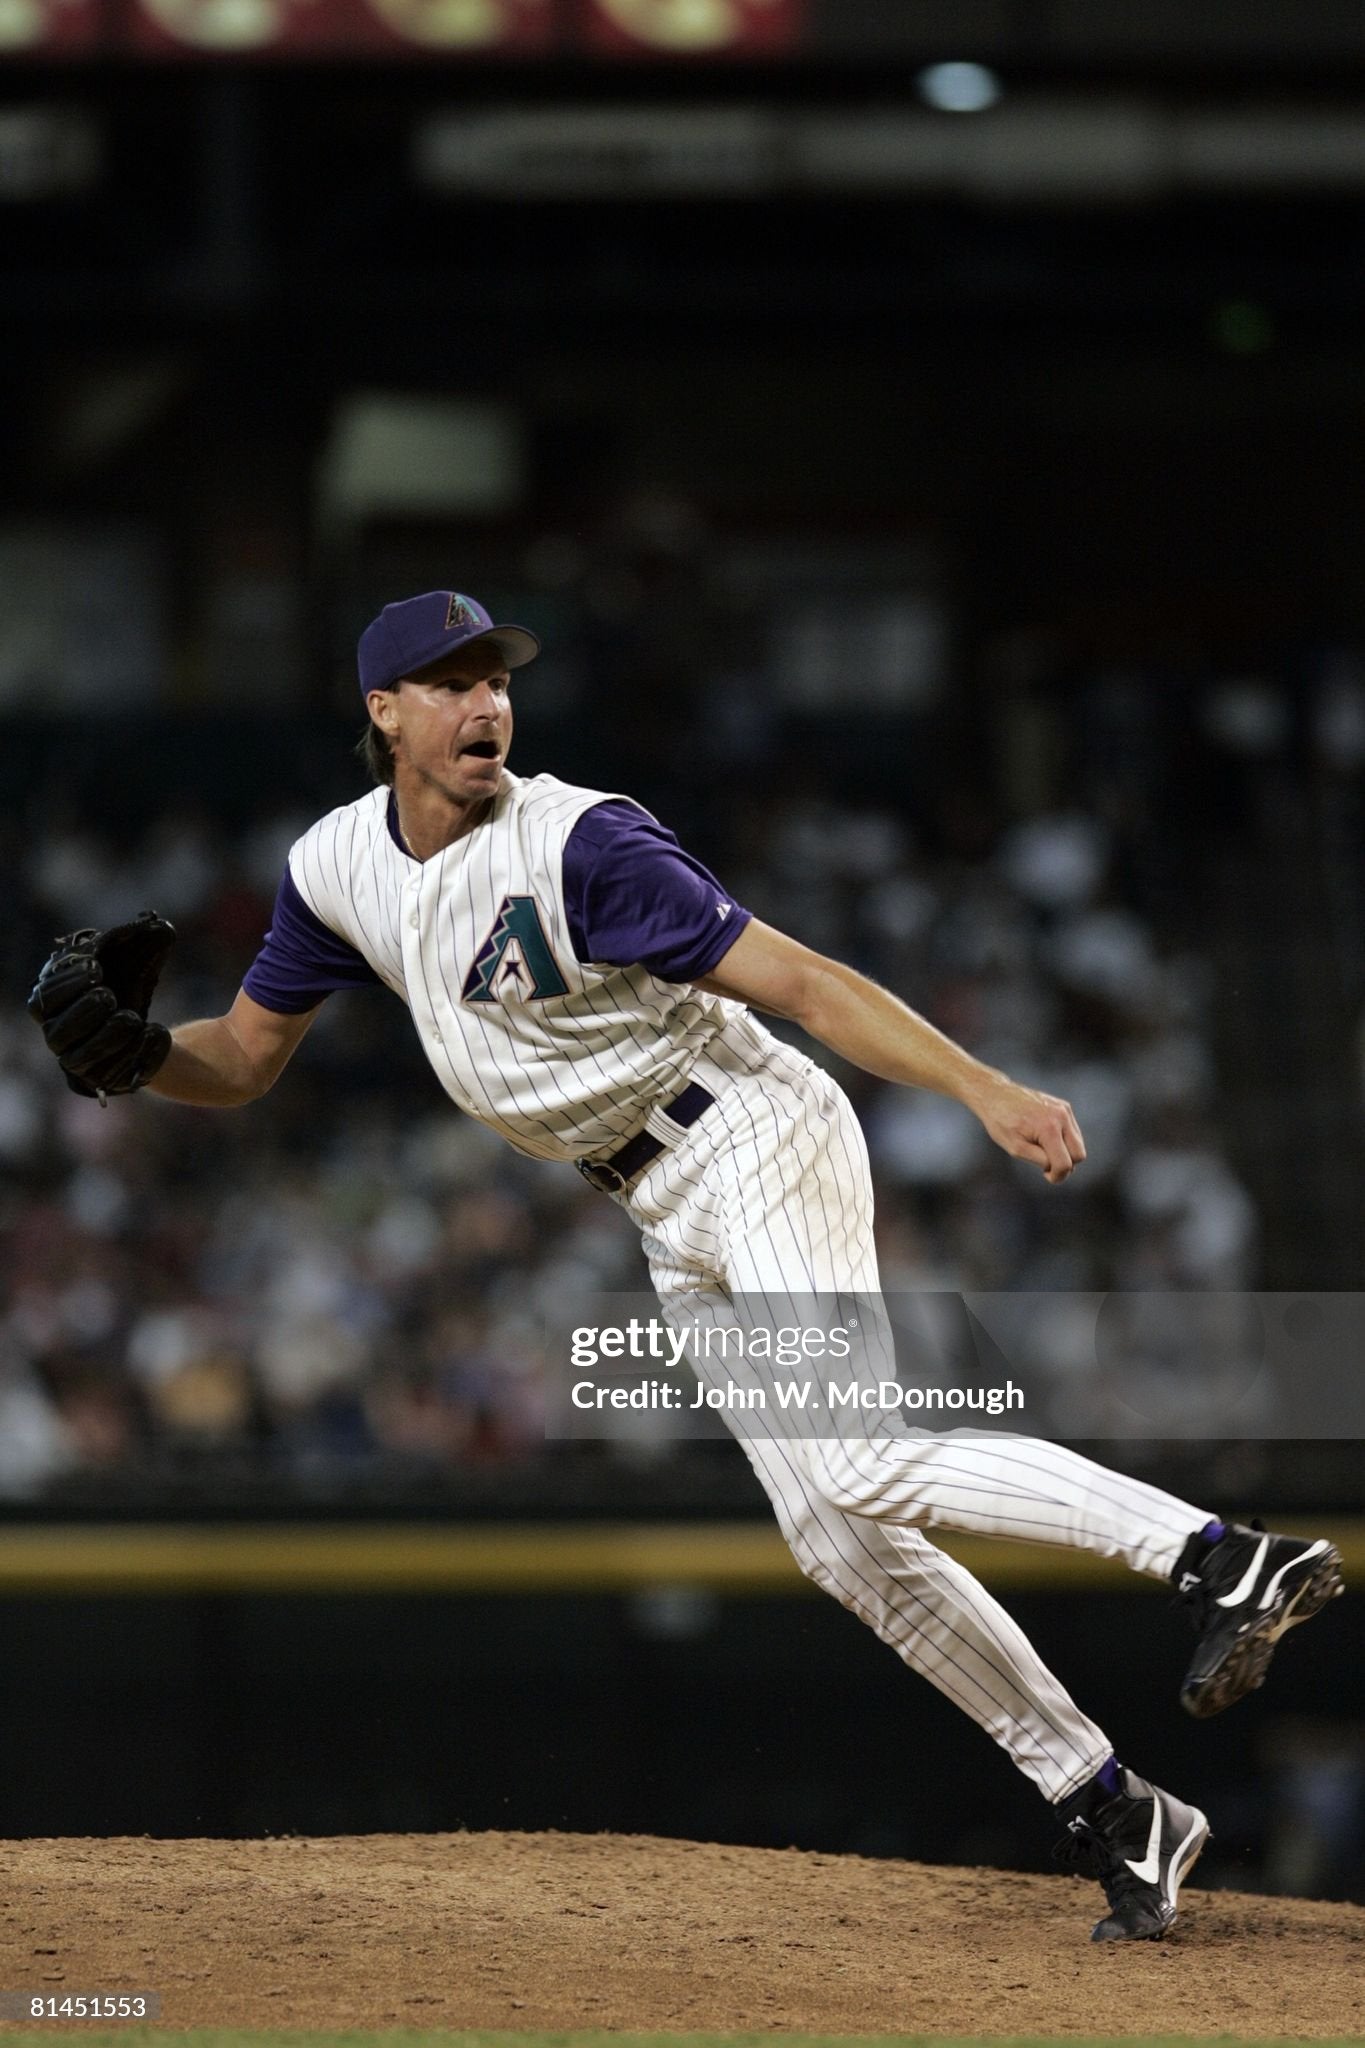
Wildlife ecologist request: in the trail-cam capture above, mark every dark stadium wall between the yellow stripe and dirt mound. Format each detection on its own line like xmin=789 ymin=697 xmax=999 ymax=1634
xmin=0 ymin=1593 xmax=1365 ymax=1896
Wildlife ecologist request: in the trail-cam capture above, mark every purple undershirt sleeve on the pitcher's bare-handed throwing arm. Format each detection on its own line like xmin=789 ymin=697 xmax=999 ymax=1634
xmin=565 ymin=801 xmax=753 ymax=981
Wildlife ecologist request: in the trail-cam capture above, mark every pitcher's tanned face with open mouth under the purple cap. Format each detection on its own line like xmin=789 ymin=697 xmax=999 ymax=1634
xmin=370 ymin=641 xmax=512 ymax=803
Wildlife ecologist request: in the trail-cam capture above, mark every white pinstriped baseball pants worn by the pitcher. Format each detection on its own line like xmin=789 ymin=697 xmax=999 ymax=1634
xmin=620 ymin=1014 xmax=1212 ymax=1802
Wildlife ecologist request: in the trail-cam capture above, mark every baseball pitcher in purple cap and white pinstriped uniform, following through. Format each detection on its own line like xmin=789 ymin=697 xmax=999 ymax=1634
xmin=29 ymin=590 xmax=1342 ymax=1942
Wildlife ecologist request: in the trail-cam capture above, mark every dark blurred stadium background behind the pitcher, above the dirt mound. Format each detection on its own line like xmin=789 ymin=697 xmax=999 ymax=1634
xmin=0 ymin=0 xmax=1365 ymax=1896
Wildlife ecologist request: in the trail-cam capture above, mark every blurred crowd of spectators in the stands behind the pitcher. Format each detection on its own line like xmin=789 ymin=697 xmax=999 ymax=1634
xmin=0 ymin=663 xmax=1259 ymax=1497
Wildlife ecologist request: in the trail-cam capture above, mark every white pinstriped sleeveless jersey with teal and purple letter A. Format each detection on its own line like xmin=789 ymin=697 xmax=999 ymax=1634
xmin=286 ymin=774 xmax=741 ymax=1159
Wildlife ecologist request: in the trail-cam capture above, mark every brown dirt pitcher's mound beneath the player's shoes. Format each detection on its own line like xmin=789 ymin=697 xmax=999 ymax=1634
xmin=0 ymin=1835 xmax=1365 ymax=2036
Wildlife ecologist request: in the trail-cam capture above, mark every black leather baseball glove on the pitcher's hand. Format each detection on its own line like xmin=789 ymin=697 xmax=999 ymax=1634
xmin=29 ymin=909 xmax=176 ymax=1102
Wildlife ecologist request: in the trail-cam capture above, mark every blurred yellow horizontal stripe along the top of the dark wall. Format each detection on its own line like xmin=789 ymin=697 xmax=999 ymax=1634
xmin=0 ymin=1516 xmax=1365 ymax=1595
